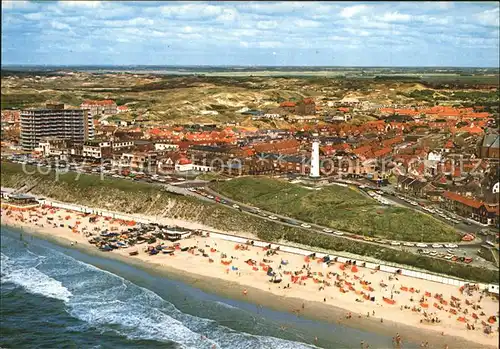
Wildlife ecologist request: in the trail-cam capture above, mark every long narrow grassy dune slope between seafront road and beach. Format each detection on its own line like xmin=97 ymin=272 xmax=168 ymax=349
xmin=0 ymin=162 xmax=499 ymax=283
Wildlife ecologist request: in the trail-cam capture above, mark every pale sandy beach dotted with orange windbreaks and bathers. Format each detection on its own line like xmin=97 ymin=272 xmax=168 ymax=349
xmin=2 ymin=207 xmax=499 ymax=348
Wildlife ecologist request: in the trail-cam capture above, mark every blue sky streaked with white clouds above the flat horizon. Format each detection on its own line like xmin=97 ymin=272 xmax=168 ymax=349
xmin=2 ymin=0 xmax=499 ymax=67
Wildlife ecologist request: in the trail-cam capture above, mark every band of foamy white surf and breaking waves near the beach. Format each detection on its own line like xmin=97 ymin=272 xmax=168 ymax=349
xmin=1 ymin=231 xmax=314 ymax=349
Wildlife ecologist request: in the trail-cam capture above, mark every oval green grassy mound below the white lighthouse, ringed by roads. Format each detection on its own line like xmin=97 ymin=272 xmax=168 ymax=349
xmin=212 ymin=177 xmax=460 ymax=242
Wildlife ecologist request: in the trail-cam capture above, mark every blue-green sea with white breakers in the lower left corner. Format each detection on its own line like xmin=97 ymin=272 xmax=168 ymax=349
xmin=0 ymin=226 xmax=417 ymax=349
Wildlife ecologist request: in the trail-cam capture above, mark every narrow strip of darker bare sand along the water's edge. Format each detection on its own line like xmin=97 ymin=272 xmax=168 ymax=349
xmin=2 ymin=223 xmax=497 ymax=349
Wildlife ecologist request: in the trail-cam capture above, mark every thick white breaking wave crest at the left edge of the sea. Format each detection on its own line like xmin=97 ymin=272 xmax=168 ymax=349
xmin=1 ymin=254 xmax=72 ymax=302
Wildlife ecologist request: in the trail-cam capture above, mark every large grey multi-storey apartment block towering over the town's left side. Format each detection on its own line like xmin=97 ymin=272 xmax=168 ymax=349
xmin=20 ymin=104 xmax=94 ymax=150
